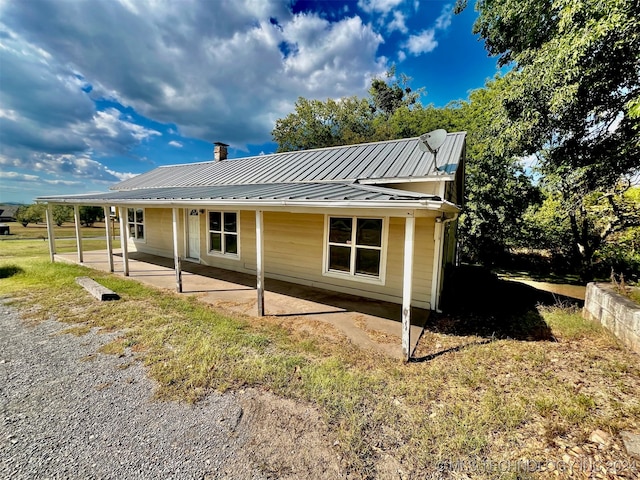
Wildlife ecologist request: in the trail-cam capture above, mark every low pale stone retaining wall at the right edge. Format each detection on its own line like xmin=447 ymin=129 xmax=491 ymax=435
xmin=582 ymin=283 xmax=640 ymax=353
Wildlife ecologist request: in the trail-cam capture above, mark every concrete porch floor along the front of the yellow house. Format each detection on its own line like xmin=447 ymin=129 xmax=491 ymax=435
xmin=55 ymin=250 xmax=429 ymax=358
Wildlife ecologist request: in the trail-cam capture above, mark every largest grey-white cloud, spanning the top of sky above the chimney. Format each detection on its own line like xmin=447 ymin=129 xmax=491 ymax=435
xmin=2 ymin=0 xmax=388 ymax=145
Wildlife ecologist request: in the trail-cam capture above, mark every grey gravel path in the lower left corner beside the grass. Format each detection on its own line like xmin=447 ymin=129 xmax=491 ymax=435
xmin=0 ymin=302 xmax=261 ymax=480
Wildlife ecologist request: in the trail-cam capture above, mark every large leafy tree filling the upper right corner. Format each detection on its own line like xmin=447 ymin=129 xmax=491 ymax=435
xmin=458 ymin=0 xmax=640 ymax=276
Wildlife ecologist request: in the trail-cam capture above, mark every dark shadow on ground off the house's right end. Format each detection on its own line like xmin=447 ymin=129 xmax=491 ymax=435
xmin=426 ymin=265 xmax=583 ymax=341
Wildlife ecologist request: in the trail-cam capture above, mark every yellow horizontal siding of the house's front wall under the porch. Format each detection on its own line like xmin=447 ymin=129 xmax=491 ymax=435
xmin=136 ymin=208 xmax=434 ymax=308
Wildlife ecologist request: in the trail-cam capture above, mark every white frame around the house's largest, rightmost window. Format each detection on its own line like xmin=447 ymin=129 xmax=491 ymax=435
xmin=322 ymin=214 xmax=389 ymax=285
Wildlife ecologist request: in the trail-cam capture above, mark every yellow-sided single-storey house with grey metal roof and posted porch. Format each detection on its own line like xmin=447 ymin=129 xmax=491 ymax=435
xmin=37 ymin=131 xmax=465 ymax=358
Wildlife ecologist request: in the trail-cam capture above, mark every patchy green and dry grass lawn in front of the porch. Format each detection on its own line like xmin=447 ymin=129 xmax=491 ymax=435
xmin=0 ymin=240 xmax=640 ymax=479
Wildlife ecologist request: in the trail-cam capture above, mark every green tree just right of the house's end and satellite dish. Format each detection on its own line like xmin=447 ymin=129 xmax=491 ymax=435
xmin=459 ymin=79 xmax=539 ymax=266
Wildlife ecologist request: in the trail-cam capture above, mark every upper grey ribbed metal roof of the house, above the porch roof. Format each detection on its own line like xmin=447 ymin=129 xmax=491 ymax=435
xmin=112 ymin=132 xmax=466 ymax=194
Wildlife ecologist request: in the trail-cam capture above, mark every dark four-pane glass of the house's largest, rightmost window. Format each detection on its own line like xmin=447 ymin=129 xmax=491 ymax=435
xmin=326 ymin=217 xmax=384 ymax=280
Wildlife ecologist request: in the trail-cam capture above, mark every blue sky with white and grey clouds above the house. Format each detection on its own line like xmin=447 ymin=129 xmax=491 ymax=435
xmin=0 ymin=0 xmax=497 ymax=203
